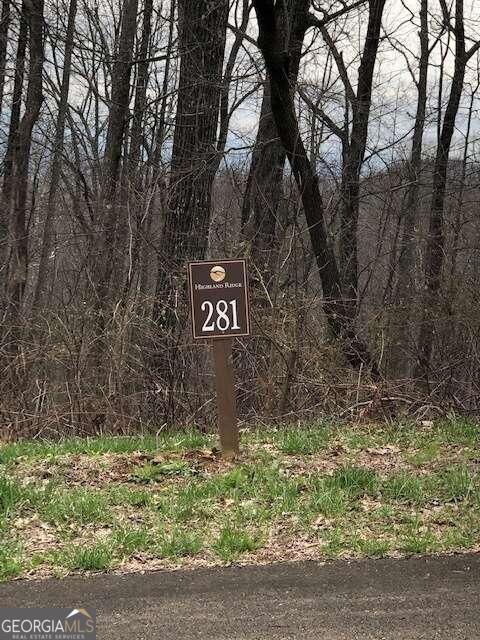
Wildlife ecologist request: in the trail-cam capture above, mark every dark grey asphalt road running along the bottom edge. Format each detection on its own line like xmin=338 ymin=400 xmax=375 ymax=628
xmin=0 ymin=554 xmax=480 ymax=640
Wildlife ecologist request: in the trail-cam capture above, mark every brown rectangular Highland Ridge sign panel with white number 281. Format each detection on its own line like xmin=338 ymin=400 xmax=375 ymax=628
xmin=188 ymin=260 xmax=250 ymax=339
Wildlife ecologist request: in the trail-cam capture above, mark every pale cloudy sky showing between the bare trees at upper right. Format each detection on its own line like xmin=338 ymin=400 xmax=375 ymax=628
xmin=226 ymin=0 xmax=480 ymax=170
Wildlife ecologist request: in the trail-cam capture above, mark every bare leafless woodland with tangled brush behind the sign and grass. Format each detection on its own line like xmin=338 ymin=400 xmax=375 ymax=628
xmin=0 ymin=0 xmax=480 ymax=438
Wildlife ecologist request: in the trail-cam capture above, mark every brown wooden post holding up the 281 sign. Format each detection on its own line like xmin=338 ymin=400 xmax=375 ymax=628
xmin=212 ymin=338 xmax=240 ymax=460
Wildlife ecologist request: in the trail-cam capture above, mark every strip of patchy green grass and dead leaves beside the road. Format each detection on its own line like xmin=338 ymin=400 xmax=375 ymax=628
xmin=0 ymin=417 xmax=480 ymax=580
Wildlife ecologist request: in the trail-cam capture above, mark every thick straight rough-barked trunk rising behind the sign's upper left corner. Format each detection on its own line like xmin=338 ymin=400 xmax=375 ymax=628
xmin=156 ymin=0 xmax=229 ymax=317
